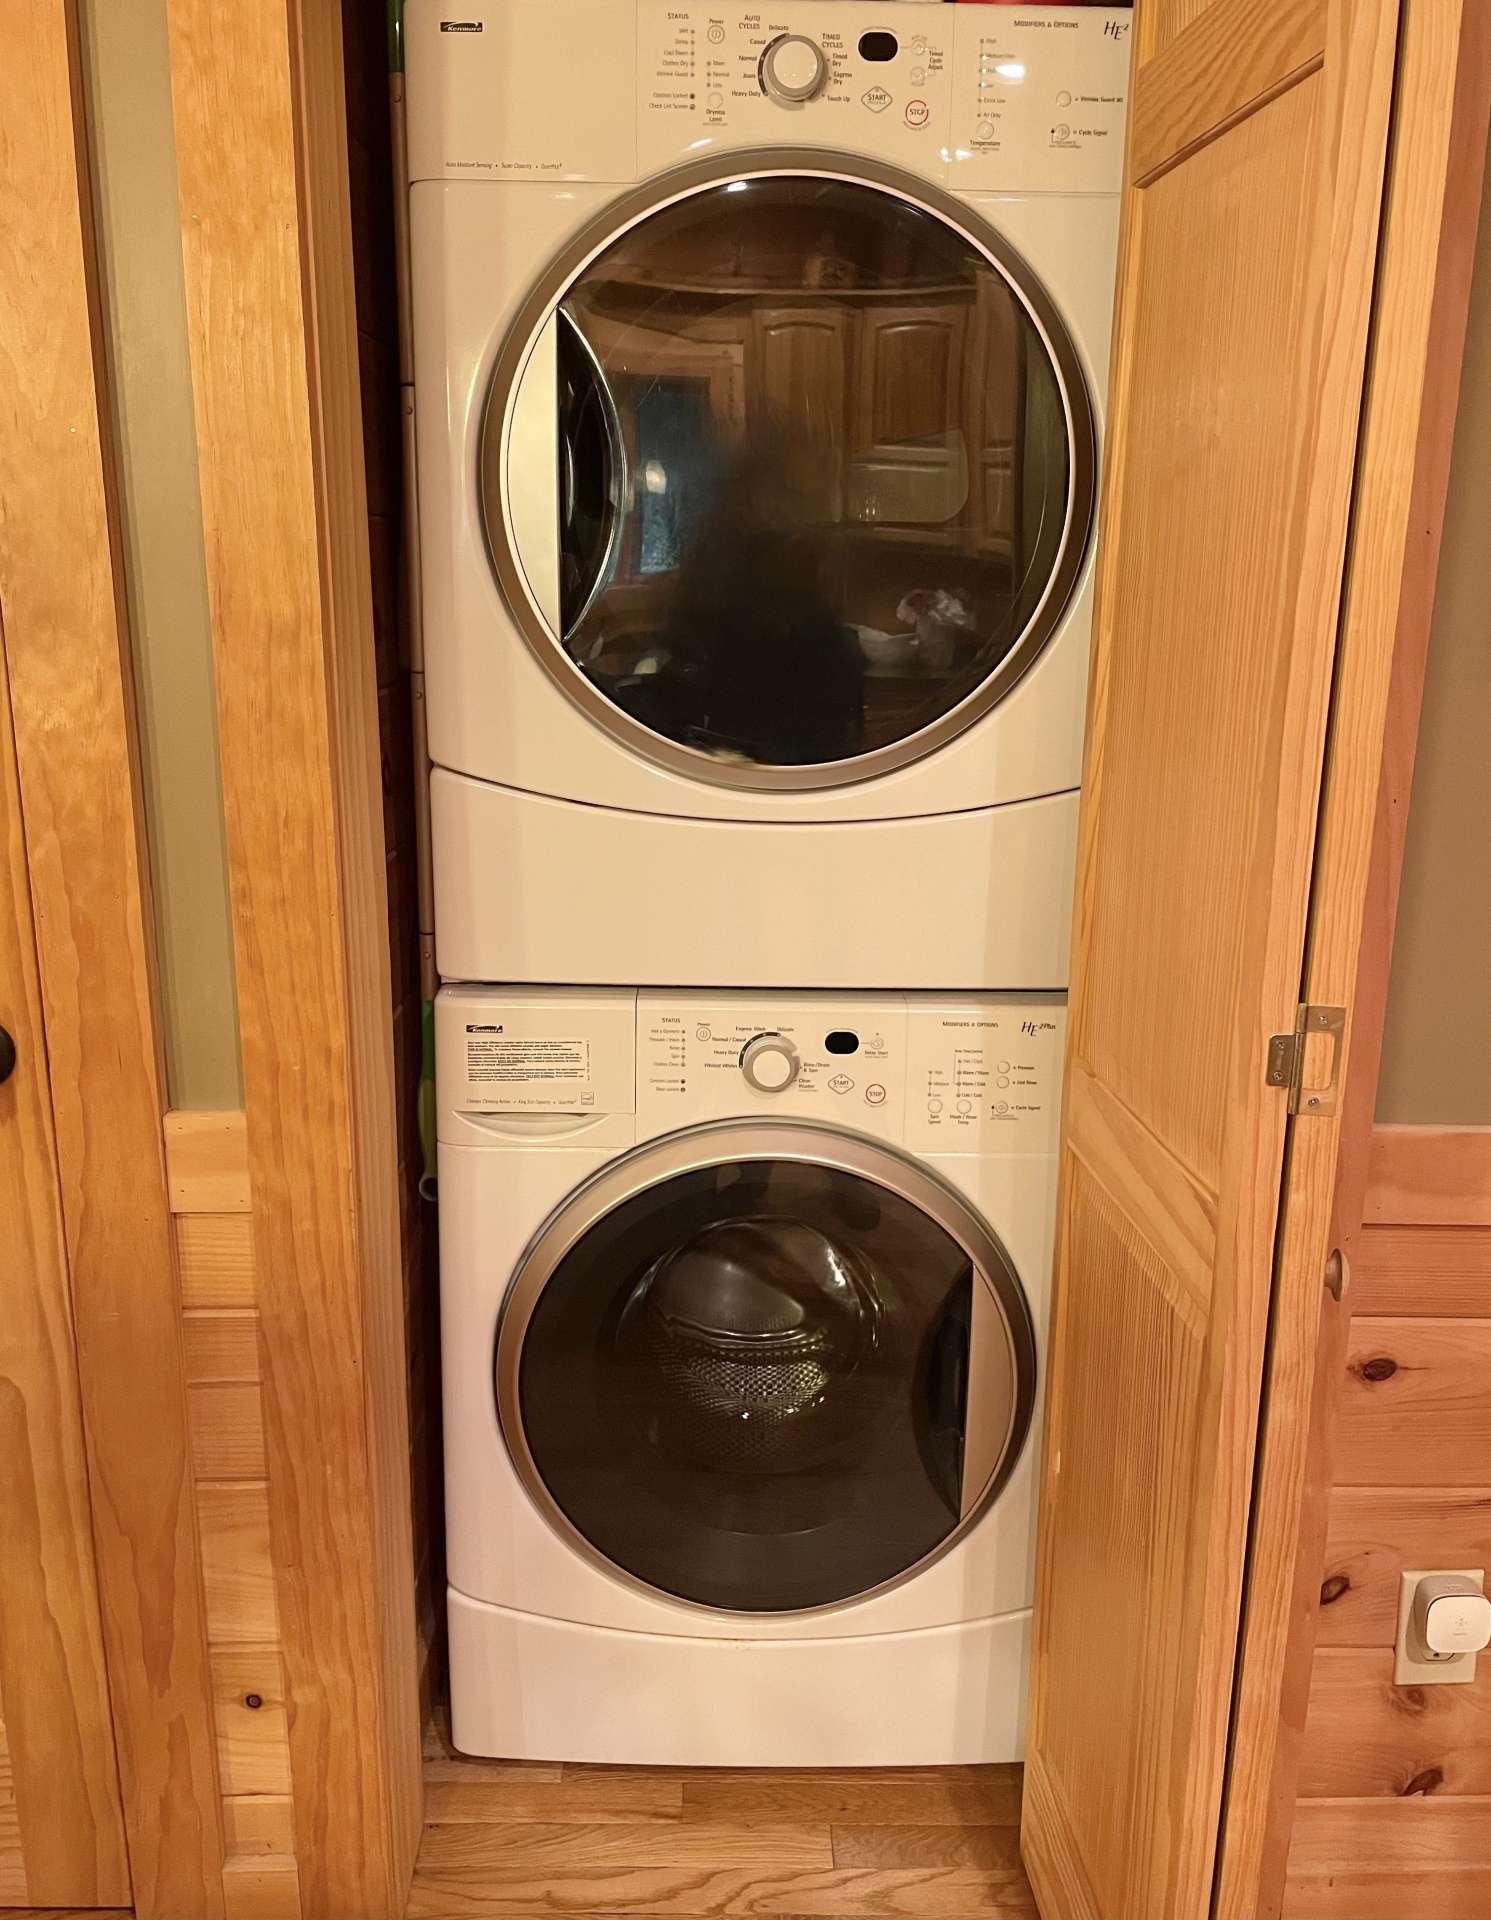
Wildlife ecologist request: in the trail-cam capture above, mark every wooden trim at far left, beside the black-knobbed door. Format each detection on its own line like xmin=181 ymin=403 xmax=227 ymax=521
xmin=0 ymin=0 xmax=223 ymax=1920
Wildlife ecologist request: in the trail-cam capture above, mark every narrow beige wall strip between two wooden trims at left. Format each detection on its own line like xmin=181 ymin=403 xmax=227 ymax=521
xmin=83 ymin=0 xmax=242 ymax=1108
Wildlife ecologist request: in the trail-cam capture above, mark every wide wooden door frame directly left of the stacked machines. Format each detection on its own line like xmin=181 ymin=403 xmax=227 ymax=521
xmin=167 ymin=0 xmax=422 ymax=1920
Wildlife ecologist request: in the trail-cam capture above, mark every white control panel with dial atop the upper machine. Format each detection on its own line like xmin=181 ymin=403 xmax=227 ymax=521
xmin=405 ymin=0 xmax=1132 ymax=194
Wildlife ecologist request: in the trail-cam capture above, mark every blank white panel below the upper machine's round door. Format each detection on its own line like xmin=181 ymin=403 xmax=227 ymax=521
xmin=430 ymin=768 xmax=1077 ymax=991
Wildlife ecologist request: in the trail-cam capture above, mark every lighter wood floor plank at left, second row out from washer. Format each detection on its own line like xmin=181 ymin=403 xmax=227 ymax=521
xmin=424 ymin=1820 xmax=833 ymax=1880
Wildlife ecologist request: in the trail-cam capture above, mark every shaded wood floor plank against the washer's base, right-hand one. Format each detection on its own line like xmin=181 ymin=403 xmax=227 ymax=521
xmin=681 ymin=1768 xmax=1021 ymax=1826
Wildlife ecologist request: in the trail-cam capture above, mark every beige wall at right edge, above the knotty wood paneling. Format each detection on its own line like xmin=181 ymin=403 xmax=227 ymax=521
xmin=1378 ymin=157 xmax=1491 ymax=1127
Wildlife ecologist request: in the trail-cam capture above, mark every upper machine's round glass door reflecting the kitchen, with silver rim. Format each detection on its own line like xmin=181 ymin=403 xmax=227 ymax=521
xmin=482 ymin=156 xmax=1096 ymax=787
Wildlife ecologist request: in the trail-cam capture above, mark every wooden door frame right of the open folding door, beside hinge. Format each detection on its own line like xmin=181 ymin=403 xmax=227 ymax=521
xmin=1215 ymin=0 xmax=1491 ymax=1920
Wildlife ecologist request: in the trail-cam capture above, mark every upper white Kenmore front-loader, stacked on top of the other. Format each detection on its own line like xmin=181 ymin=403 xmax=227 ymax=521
xmin=405 ymin=0 xmax=1130 ymax=989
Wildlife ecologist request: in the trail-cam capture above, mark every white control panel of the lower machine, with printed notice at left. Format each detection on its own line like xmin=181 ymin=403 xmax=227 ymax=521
xmin=436 ymin=987 xmax=1067 ymax=1154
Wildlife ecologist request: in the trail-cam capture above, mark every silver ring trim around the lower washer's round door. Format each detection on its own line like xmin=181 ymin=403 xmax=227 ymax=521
xmin=493 ymin=1119 xmax=1036 ymax=1620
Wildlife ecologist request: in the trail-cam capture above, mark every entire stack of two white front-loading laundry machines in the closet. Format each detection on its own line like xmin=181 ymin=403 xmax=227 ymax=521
xmin=405 ymin=0 xmax=1130 ymax=1766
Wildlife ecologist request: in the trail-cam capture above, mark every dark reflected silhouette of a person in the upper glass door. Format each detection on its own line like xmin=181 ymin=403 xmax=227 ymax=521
xmin=666 ymin=432 xmax=864 ymax=766
